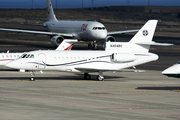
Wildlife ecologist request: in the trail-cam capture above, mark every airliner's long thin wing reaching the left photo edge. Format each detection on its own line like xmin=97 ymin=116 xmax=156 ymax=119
xmin=0 ymin=28 xmax=73 ymax=37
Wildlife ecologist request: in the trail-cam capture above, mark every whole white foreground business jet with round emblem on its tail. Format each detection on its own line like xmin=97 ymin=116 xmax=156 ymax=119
xmin=6 ymin=20 xmax=172 ymax=81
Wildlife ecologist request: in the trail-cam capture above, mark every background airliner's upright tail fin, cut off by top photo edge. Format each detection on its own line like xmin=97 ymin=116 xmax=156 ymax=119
xmin=46 ymin=0 xmax=57 ymax=21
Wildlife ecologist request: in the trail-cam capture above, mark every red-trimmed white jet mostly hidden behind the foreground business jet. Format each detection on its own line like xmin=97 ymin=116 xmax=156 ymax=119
xmin=0 ymin=39 xmax=77 ymax=66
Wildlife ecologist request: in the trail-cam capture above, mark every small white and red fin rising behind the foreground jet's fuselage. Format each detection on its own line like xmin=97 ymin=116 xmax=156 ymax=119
xmin=56 ymin=39 xmax=78 ymax=50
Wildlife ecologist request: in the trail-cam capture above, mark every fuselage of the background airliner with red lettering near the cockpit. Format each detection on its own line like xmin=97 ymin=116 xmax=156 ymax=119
xmin=44 ymin=21 xmax=107 ymax=41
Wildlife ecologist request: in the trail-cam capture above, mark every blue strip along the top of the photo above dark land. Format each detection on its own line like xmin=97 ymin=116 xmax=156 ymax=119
xmin=0 ymin=0 xmax=180 ymax=9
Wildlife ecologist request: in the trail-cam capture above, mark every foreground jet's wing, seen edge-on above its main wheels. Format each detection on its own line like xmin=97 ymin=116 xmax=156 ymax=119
xmin=75 ymin=68 xmax=144 ymax=72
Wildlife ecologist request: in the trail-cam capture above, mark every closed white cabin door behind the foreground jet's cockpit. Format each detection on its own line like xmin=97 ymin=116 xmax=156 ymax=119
xmin=38 ymin=53 xmax=46 ymax=69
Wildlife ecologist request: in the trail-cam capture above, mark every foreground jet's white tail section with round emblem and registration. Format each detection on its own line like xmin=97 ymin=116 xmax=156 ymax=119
xmin=106 ymin=20 xmax=173 ymax=53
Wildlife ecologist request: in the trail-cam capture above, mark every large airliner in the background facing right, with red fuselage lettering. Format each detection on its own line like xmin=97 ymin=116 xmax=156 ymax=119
xmin=0 ymin=0 xmax=138 ymax=49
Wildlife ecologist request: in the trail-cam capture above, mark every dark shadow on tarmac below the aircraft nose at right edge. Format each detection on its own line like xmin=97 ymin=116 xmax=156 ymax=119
xmin=136 ymin=86 xmax=180 ymax=91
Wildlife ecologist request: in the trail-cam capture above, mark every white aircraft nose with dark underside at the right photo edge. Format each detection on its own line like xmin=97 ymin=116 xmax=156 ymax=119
xmin=162 ymin=61 xmax=180 ymax=78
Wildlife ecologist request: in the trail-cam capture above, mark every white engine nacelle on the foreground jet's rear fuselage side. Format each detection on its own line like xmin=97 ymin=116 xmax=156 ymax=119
xmin=111 ymin=53 xmax=137 ymax=63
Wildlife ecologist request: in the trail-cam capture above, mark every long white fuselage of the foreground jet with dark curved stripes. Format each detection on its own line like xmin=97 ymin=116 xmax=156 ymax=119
xmin=6 ymin=50 xmax=158 ymax=72
